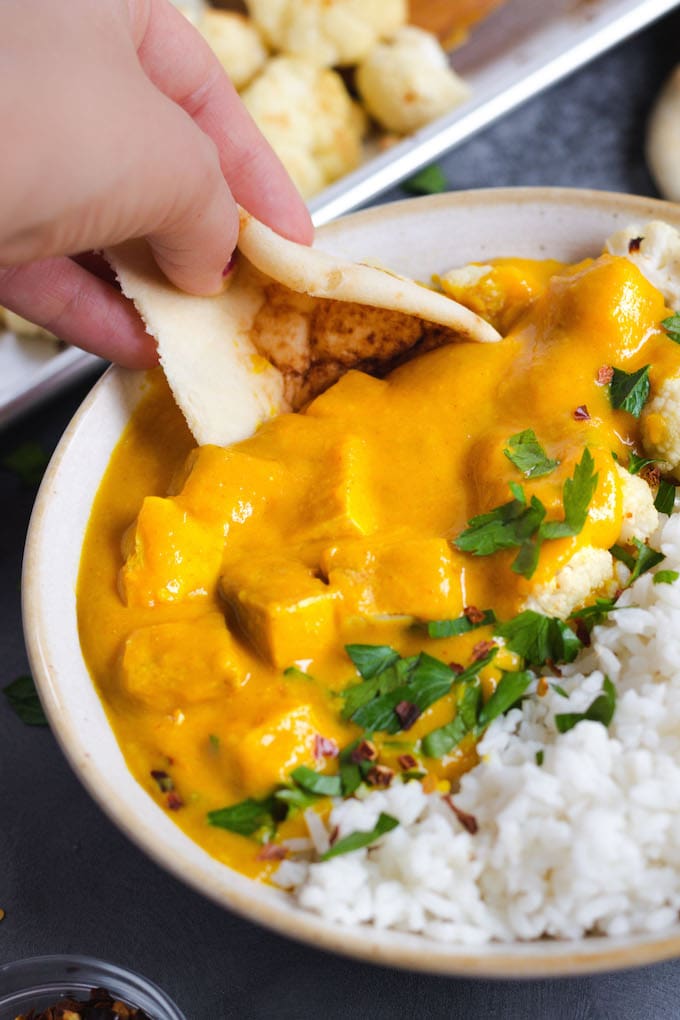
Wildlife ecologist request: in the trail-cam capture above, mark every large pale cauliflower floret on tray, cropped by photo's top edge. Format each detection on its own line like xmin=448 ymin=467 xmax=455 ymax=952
xmin=247 ymin=0 xmax=408 ymax=67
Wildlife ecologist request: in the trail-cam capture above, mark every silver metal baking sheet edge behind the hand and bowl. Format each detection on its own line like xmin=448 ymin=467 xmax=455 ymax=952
xmin=0 ymin=0 xmax=679 ymax=427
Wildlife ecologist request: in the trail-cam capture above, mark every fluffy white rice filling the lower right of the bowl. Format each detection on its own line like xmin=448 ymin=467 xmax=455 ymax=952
xmin=279 ymin=514 xmax=680 ymax=945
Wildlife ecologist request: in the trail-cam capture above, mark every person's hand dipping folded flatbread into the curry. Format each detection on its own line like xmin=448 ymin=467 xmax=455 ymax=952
xmin=0 ymin=0 xmax=312 ymax=367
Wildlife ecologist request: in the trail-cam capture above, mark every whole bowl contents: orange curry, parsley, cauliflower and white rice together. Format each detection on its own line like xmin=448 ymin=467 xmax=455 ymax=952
xmin=71 ymin=198 xmax=680 ymax=942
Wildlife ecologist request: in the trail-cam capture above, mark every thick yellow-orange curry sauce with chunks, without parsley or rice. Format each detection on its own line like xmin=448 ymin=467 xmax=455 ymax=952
xmin=77 ymin=255 xmax=680 ymax=876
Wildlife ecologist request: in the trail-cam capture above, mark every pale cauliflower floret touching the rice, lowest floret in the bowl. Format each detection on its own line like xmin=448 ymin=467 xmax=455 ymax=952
xmin=523 ymin=546 xmax=616 ymax=620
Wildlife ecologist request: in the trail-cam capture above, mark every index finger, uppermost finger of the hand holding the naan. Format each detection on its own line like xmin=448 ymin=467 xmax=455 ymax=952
xmin=127 ymin=0 xmax=314 ymax=244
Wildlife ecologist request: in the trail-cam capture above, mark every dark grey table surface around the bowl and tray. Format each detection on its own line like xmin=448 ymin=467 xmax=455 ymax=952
xmin=0 ymin=10 xmax=680 ymax=1020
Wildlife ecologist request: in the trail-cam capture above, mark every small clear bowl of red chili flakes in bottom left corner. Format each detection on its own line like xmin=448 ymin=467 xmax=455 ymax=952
xmin=0 ymin=956 xmax=187 ymax=1020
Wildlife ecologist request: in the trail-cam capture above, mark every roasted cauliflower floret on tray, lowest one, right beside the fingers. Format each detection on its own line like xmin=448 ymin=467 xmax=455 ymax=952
xmin=242 ymin=56 xmax=366 ymax=198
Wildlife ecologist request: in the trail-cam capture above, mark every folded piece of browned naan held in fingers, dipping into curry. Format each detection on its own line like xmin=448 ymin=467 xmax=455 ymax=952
xmin=106 ymin=211 xmax=501 ymax=446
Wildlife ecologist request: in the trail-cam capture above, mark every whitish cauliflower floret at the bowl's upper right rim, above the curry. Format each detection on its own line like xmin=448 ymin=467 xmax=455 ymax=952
xmin=605 ymin=220 xmax=680 ymax=309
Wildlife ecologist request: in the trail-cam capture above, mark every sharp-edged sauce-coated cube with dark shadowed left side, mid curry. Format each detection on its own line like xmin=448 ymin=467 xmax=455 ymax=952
xmin=220 ymin=559 xmax=337 ymax=669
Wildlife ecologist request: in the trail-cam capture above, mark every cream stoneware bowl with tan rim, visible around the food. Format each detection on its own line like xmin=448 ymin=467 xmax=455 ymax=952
xmin=23 ymin=189 xmax=680 ymax=977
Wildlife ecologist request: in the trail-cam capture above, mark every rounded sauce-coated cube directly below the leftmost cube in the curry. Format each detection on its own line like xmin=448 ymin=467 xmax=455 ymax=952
xmin=119 ymin=612 xmax=248 ymax=712
